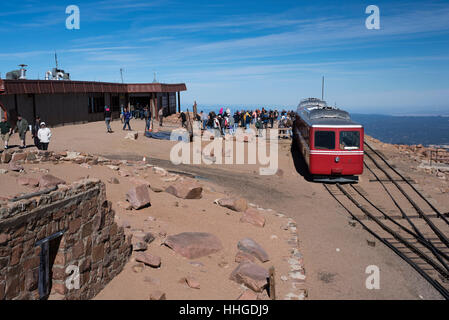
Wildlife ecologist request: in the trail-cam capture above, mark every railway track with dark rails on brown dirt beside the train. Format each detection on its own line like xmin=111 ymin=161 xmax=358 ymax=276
xmin=324 ymin=143 xmax=449 ymax=300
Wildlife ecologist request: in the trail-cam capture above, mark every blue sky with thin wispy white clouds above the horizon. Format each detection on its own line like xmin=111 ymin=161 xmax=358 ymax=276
xmin=0 ymin=0 xmax=449 ymax=115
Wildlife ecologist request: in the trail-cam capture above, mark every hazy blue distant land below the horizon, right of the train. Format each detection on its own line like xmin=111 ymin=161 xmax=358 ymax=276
xmin=351 ymin=114 xmax=449 ymax=146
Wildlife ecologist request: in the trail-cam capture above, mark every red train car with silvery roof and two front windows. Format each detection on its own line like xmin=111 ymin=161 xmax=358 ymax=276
xmin=293 ymin=98 xmax=364 ymax=182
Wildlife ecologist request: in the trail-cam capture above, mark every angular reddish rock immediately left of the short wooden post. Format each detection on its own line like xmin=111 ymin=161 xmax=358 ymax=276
xmin=230 ymin=262 xmax=269 ymax=292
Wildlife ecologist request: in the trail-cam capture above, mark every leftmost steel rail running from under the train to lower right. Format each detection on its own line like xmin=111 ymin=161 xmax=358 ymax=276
xmin=323 ymin=184 xmax=449 ymax=300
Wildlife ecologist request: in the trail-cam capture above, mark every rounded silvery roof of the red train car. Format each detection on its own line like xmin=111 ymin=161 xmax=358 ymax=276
xmin=296 ymin=98 xmax=362 ymax=128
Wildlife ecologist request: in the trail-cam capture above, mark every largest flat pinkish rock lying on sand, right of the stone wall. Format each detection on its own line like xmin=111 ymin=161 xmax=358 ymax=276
xmin=164 ymin=232 xmax=223 ymax=259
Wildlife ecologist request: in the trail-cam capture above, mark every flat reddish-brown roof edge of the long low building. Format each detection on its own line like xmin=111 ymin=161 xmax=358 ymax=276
xmin=0 ymin=79 xmax=187 ymax=94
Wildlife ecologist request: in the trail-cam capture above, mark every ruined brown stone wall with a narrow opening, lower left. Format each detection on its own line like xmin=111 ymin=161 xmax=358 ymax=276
xmin=0 ymin=179 xmax=132 ymax=300
